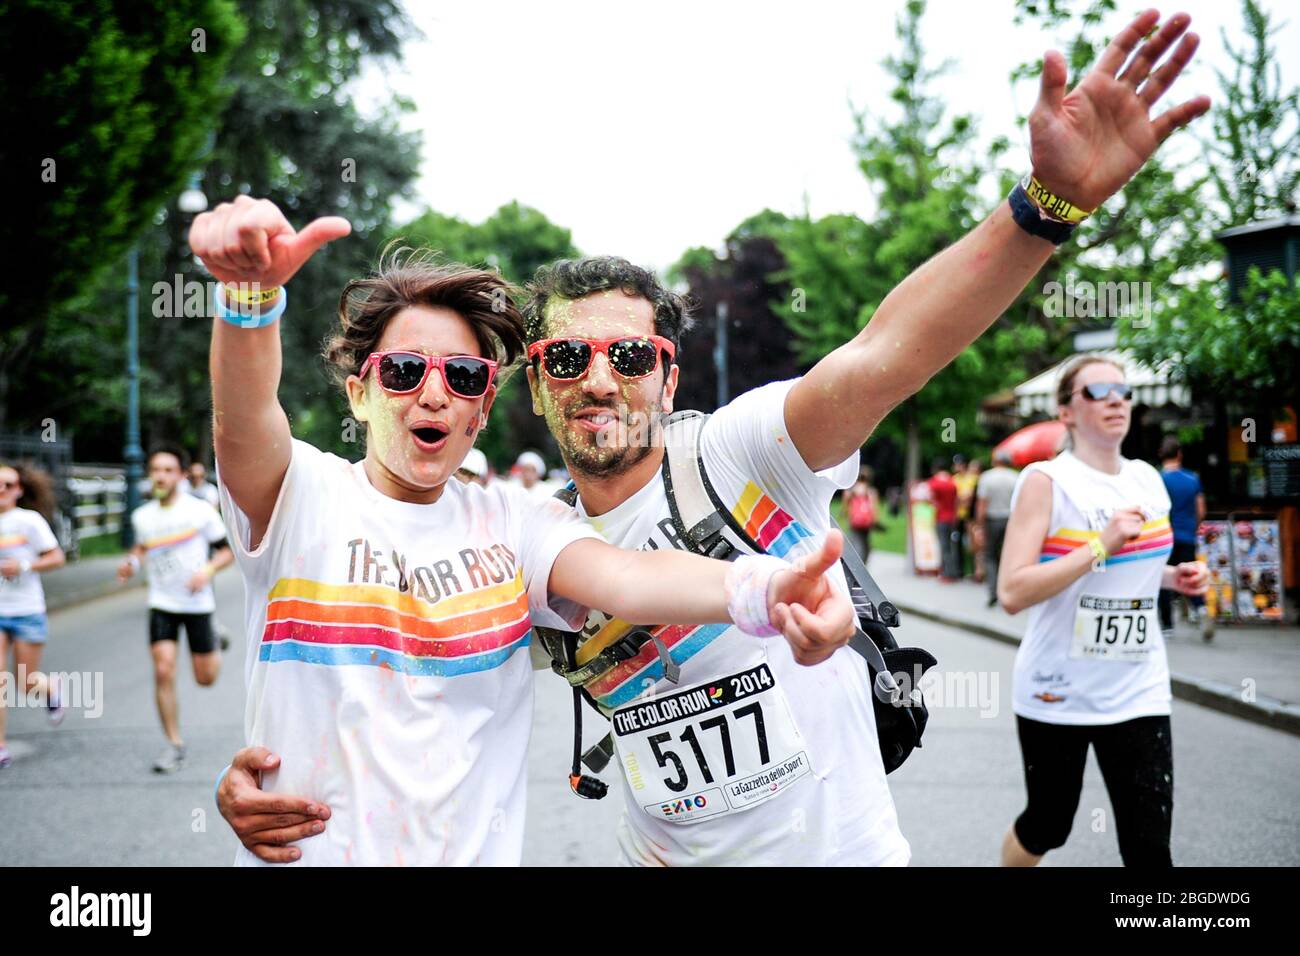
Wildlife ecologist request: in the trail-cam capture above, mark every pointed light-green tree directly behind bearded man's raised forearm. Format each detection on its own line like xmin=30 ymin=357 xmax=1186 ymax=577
xmin=779 ymin=0 xmax=1041 ymax=480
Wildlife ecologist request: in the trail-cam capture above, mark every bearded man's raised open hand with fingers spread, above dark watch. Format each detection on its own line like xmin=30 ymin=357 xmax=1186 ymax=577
xmin=1030 ymin=10 xmax=1210 ymax=209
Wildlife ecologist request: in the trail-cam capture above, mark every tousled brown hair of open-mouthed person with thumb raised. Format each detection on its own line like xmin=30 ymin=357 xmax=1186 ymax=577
xmin=322 ymin=239 xmax=525 ymax=388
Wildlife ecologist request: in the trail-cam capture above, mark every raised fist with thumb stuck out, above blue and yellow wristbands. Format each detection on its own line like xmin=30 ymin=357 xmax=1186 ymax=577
xmin=190 ymin=195 xmax=352 ymax=289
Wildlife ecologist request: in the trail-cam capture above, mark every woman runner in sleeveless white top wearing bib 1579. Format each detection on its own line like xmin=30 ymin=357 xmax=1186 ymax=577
xmin=998 ymin=355 xmax=1209 ymax=866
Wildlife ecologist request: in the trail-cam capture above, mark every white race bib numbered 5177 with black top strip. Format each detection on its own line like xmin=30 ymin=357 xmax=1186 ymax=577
xmin=610 ymin=663 xmax=811 ymax=823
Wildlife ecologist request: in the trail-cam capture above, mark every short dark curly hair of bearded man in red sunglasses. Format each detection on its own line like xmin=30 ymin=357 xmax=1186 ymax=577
xmin=521 ymin=256 xmax=692 ymax=351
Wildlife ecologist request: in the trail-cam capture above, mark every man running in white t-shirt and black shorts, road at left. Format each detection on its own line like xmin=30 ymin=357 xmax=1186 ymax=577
xmin=117 ymin=449 xmax=233 ymax=774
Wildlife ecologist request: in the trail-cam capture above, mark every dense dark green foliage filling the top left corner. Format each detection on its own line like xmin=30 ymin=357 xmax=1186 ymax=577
xmin=0 ymin=0 xmax=246 ymax=431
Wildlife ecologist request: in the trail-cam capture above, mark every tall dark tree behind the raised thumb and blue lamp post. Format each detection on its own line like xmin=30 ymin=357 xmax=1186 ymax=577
xmin=2 ymin=0 xmax=420 ymax=460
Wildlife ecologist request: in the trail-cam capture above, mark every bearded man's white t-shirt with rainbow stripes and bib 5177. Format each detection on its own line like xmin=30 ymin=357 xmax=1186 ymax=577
xmin=579 ymin=381 xmax=910 ymax=865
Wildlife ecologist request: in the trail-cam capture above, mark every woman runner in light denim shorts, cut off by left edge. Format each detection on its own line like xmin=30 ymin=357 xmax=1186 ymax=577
xmin=0 ymin=463 xmax=64 ymax=770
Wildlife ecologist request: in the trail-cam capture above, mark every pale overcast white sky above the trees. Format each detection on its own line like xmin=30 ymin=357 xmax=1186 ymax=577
xmin=359 ymin=0 xmax=1300 ymax=268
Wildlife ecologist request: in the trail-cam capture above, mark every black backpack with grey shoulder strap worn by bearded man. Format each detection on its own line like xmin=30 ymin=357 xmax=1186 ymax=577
xmin=533 ymin=411 xmax=937 ymax=797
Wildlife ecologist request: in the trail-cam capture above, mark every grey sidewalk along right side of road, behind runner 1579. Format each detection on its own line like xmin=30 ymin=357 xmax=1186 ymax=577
xmin=870 ymin=551 xmax=1300 ymax=735
